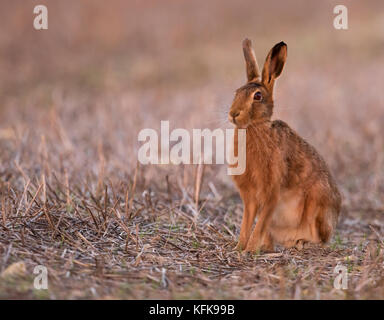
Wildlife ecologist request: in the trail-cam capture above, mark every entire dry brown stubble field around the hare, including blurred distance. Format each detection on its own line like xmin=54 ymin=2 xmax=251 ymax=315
xmin=0 ymin=0 xmax=384 ymax=299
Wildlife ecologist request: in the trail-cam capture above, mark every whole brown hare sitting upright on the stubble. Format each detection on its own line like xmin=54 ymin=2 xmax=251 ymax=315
xmin=229 ymin=39 xmax=341 ymax=252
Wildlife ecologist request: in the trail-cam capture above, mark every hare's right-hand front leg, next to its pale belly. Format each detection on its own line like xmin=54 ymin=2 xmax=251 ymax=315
xmin=245 ymin=195 xmax=278 ymax=252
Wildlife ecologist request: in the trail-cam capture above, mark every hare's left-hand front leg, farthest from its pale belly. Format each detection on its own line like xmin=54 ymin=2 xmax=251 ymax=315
xmin=235 ymin=195 xmax=259 ymax=251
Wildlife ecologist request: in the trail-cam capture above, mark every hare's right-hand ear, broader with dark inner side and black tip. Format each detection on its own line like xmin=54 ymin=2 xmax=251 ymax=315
xmin=262 ymin=41 xmax=287 ymax=85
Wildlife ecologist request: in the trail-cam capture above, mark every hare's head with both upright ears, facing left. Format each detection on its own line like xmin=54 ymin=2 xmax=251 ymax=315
xmin=228 ymin=39 xmax=287 ymax=128
